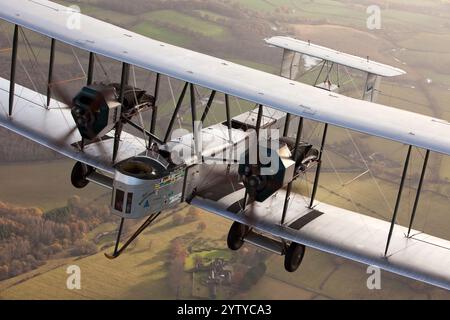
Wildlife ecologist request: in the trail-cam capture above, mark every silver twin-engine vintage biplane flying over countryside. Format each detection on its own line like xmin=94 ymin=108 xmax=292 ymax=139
xmin=0 ymin=0 xmax=450 ymax=289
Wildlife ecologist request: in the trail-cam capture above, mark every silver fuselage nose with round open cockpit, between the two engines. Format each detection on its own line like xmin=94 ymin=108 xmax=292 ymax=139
xmin=111 ymin=155 xmax=185 ymax=219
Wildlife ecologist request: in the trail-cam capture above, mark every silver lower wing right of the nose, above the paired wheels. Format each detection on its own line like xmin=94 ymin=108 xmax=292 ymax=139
xmin=191 ymin=189 xmax=450 ymax=290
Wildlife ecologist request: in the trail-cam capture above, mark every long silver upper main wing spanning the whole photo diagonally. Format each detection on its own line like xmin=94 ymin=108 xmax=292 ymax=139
xmin=0 ymin=0 xmax=450 ymax=154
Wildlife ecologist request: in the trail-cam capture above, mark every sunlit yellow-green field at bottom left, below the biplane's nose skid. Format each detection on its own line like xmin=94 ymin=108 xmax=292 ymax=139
xmin=0 ymin=206 xmax=232 ymax=299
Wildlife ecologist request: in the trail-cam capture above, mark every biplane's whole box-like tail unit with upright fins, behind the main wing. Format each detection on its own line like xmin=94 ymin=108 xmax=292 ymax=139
xmin=265 ymin=36 xmax=406 ymax=102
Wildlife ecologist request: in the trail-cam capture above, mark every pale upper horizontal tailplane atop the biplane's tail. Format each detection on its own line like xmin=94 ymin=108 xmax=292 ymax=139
xmin=266 ymin=36 xmax=406 ymax=77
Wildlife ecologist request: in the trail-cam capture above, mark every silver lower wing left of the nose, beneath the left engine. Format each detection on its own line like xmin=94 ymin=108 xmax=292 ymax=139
xmin=0 ymin=78 xmax=146 ymax=174
